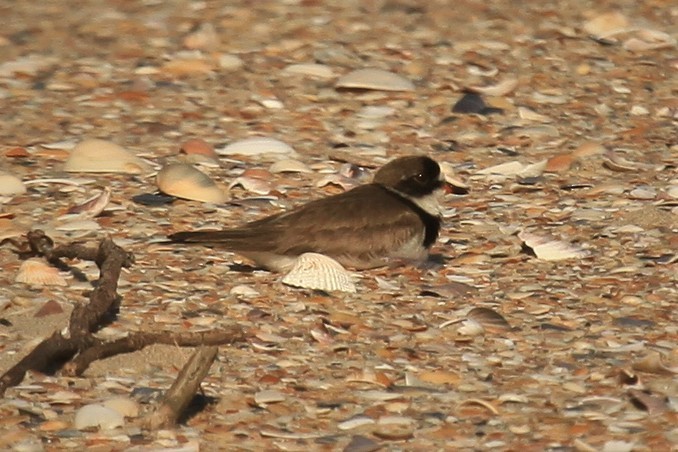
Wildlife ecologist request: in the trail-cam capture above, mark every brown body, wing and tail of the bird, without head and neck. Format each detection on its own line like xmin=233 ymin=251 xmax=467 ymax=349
xmin=170 ymin=184 xmax=437 ymax=262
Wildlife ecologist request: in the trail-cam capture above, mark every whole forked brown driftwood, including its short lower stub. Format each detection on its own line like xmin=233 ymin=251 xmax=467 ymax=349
xmin=0 ymin=230 xmax=245 ymax=402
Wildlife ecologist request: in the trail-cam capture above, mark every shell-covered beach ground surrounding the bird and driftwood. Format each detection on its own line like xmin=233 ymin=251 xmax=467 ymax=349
xmin=0 ymin=0 xmax=678 ymax=451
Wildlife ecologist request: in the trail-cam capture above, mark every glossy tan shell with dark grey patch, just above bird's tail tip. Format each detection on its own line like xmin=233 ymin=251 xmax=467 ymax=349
xmin=155 ymin=163 xmax=226 ymax=204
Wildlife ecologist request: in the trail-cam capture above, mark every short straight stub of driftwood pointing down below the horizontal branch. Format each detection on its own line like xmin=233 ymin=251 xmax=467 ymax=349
xmin=145 ymin=346 xmax=219 ymax=430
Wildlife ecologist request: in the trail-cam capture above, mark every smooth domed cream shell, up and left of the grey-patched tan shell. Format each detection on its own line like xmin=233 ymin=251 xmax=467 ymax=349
xmin=64 ymin=139 xmax=150 ymax=174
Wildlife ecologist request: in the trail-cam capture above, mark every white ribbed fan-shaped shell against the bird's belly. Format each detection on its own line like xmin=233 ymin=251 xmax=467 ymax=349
xmin=282 ymin=253 xmax=356 ymax=293
